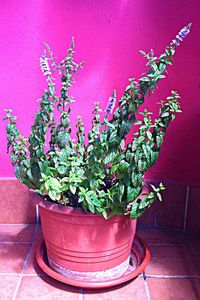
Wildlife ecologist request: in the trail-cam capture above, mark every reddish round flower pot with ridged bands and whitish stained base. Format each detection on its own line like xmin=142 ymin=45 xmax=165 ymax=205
xmin=38 ymin=198 xmax=136 ymax=278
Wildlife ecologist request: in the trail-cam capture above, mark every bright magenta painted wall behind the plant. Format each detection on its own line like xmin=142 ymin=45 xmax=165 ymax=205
xmin=0 ymin=0 xmax=200 ymax=185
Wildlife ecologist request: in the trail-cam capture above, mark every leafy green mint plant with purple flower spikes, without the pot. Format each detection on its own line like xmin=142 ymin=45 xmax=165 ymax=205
xmin=2 ymin=24 xmax=191 ymax=219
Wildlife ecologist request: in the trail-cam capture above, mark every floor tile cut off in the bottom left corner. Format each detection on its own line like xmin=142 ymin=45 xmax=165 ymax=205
xmin=0 ymin=275 xmax=20 ymax=300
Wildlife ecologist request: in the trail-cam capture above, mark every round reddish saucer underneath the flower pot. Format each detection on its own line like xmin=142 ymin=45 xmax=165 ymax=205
xmin=36 ymin=236 xmax=150 ymax=289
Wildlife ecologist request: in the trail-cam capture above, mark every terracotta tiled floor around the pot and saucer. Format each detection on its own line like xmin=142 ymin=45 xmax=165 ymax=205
xmin=0 ymin=225 xmax=200 ymax=300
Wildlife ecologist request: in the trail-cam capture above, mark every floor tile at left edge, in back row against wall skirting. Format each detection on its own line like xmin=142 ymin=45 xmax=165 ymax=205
xmin=0 ymin=224 xmax=35 ymax=242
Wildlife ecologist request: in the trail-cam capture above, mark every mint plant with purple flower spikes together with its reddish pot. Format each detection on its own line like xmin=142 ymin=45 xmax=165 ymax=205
xmin=5 ymin=24 xmax=191 ymax=284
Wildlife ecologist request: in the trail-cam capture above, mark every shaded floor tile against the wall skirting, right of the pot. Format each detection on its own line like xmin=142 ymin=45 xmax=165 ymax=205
xmin=137 ymin=225 xmax=186 ymax=244
